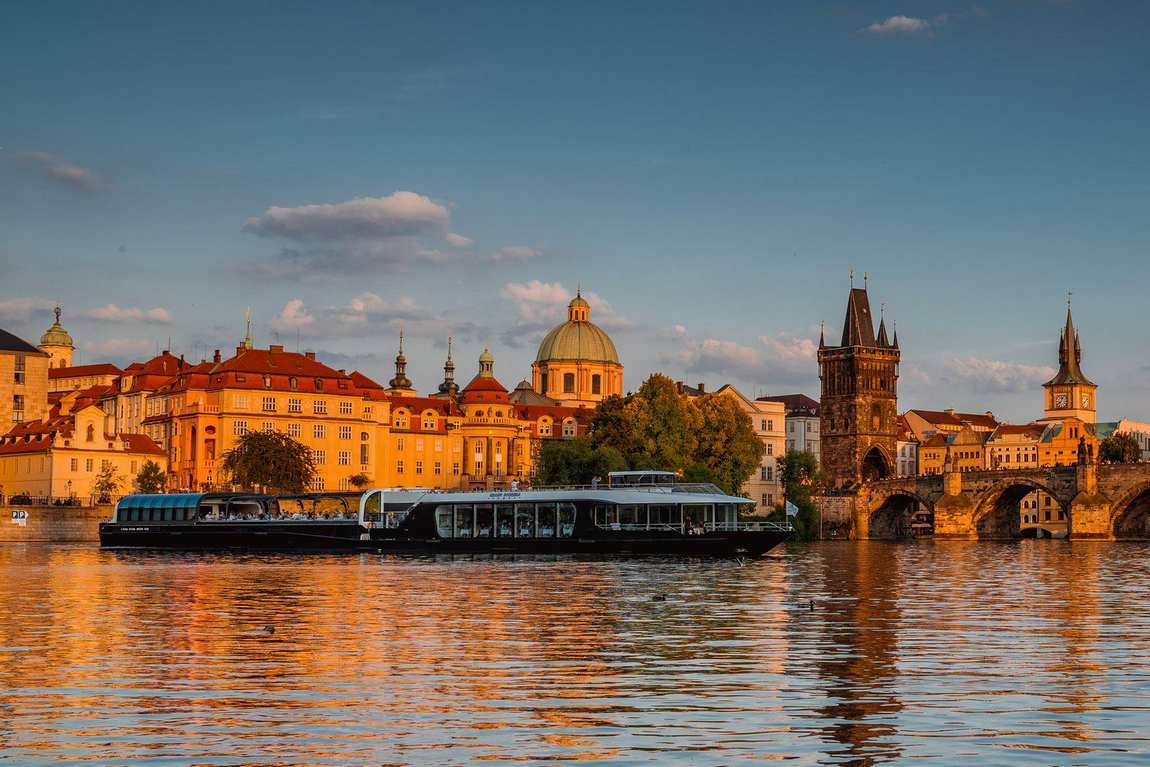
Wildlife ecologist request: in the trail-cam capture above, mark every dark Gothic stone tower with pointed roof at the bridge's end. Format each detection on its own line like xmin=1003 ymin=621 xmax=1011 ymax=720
xmin=819 ymin=278 xmax=899 ymax=489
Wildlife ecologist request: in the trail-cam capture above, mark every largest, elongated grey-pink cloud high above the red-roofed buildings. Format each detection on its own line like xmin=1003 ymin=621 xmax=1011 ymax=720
xmin=244 ymin=191 xmax=450 ymax=241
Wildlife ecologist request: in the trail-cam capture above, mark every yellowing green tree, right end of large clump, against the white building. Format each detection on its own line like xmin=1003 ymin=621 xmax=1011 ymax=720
xmin=689 ymin=394 xmax=766 ymax=496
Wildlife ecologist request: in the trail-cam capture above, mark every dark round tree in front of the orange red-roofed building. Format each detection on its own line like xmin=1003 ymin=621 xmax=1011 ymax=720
xmin=223 ymin=431 xmax=315 ymax=492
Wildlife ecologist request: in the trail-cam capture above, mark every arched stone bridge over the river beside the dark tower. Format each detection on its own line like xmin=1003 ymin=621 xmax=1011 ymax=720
xmin=844 ymin=462 xmax=1150 ymax=540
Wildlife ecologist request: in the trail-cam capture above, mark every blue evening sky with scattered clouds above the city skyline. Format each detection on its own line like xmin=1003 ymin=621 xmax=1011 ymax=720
xmin=0 ymin=0 xmax=1150 ymax=420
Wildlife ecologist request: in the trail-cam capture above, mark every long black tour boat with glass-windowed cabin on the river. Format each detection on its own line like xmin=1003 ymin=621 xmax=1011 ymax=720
xmin=100 ymin=471 xmax=792 ymax=557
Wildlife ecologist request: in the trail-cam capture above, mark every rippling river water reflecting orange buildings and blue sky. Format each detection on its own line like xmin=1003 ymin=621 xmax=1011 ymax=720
xmin=0 ymin=540 xmax=1150 ymax=765
